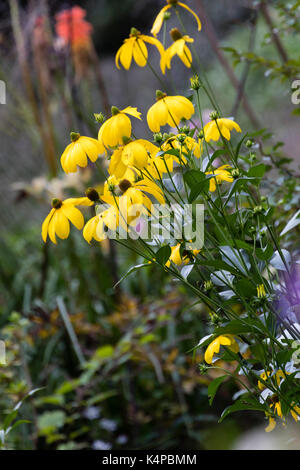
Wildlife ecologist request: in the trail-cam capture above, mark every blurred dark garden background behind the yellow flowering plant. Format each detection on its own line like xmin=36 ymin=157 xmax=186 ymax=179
xmin=0 ymin=0 xmax=300 ymax=449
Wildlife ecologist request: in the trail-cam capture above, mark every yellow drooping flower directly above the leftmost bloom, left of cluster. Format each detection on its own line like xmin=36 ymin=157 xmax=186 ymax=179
xmin=60 ymin=132 xmax=105 ymax=173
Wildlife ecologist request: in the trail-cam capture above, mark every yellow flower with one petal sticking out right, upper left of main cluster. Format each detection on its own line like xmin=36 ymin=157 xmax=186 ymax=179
xmin=98 ymin=106 xmax=141 ymax=147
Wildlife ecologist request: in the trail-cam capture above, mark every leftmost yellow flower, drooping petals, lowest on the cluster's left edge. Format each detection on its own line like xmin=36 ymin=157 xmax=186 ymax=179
xmin=42 ymin=197 xmax=94 ymax=243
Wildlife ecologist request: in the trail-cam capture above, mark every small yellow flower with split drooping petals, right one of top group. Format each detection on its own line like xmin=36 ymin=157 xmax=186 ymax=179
xmin=160 ymin=28 xmax=194 ymax=73
